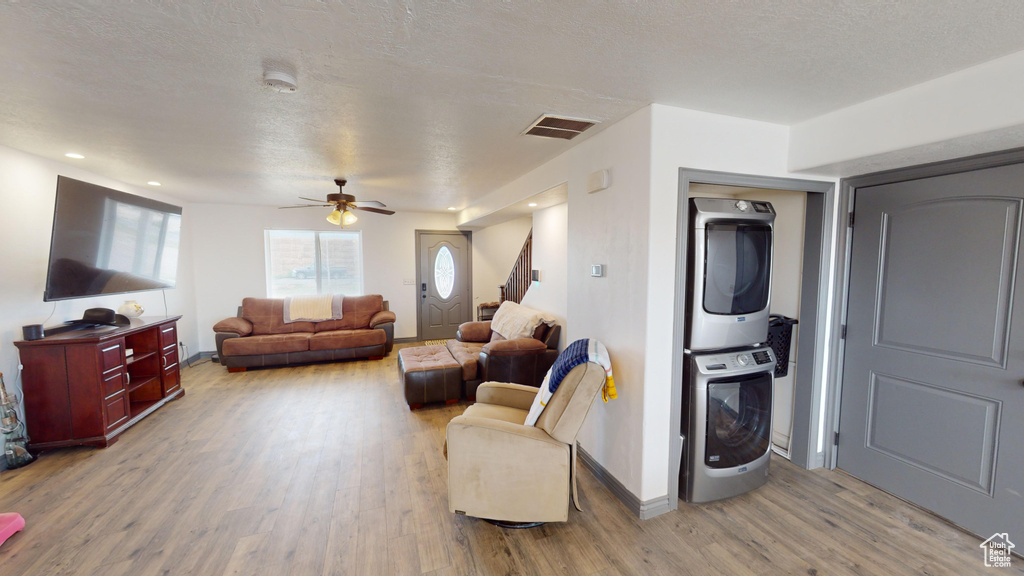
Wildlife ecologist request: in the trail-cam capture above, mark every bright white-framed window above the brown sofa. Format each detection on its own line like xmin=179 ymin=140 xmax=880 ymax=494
xmin=266 ymin=230 xmax=362 ymax=298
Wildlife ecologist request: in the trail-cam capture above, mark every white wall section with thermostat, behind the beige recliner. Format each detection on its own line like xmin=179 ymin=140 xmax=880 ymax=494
xmin=565 ymin=108 xmax=651 ymax=499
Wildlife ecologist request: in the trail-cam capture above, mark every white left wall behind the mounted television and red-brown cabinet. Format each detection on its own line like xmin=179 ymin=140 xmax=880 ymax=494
xmin=0 ymin=147 xmax=198 ymax=422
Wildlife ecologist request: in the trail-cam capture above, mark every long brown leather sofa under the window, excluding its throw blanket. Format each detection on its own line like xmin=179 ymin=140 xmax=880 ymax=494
xmin=213 ymin=294 xmax=395 ymax=372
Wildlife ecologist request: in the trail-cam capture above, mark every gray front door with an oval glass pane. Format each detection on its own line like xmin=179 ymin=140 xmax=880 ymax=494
xmin=417 ymin=231 xmax=473 ymax=340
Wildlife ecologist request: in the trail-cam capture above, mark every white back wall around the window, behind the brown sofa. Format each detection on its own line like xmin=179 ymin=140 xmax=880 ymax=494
xmin=190 ymin=204 xmax=456 ymax=344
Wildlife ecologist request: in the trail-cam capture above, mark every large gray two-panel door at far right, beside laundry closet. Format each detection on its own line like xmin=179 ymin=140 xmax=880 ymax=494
xmin=838 ymin=158 xmax=1024 ymax=538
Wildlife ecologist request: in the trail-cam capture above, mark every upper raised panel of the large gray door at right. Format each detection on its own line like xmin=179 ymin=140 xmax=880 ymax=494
xmin=874 ymin=198 xmax=1020 ymax=367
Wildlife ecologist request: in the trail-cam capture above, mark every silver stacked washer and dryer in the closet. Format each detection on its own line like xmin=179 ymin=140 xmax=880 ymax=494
xmin=679 ymin=198 xmax=775 ymax=502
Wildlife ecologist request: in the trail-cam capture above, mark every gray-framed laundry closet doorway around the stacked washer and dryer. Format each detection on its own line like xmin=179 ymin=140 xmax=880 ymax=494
xmin=669 ymin=168 xmax=836 ymax=507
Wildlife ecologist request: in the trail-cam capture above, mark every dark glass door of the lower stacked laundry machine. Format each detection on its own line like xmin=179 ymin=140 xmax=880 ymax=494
xmin=705 ymin=372 xmax=772 ymax=468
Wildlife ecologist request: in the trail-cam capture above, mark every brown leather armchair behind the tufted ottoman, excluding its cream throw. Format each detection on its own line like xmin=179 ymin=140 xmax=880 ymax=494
xmin=445 ymin=321 xmax=561 ymax=400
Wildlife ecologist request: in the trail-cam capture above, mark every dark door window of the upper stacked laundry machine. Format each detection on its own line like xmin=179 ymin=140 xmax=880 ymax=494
xmin=703 ymin=222 xmax=771 ymax=315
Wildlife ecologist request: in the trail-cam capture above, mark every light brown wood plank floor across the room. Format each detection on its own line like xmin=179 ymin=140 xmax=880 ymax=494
xmin=0 ymin=342 xmax=1007 ymax=576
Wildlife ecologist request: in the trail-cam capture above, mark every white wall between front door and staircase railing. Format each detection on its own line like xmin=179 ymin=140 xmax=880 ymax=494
xmin=473 ymin=216 xmax=534 ymax=307
